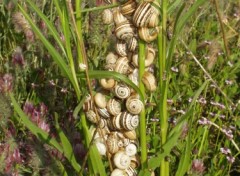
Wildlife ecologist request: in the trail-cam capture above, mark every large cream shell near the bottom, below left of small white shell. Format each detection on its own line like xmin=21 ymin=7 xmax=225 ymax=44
xmin=113 ymin=151 xmax=131 ymax=169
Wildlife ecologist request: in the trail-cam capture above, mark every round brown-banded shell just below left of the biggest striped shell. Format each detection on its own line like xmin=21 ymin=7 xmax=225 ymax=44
xmin=115 ymin=21 xmax=135 ymax=41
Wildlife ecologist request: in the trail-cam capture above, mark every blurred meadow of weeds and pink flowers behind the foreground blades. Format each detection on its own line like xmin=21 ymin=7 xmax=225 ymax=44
xmin=0 ymin=0 xmax=240 ymax=176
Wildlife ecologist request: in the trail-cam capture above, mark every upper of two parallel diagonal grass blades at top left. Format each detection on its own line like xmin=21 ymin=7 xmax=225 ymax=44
xmin=23 ymin=0 xmax=66 ymax=56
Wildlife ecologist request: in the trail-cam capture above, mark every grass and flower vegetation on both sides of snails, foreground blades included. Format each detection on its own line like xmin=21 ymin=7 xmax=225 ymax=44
xmin=0 ymin=0 xmax=240 ymax=176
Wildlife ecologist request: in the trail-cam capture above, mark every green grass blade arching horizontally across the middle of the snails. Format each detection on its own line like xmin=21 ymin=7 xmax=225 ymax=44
xmin=77 ymin=70 xmax=144 ymax=100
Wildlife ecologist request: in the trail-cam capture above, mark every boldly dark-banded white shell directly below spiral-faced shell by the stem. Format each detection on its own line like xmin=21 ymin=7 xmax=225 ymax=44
xmin=120 ymin=112 xmax=139 ymax=130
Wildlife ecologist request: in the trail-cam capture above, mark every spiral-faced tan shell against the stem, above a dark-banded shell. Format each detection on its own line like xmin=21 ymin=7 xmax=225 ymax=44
xmin=126 ymin=95 xmax=143 ymax=114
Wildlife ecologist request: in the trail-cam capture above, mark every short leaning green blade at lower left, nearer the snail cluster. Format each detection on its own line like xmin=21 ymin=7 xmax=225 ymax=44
xmin=54 ymin=113 xmax=81 ymax=172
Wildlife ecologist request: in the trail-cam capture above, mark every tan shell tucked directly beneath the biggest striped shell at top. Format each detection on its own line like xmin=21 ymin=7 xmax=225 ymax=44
xmin=138 ymin=27 xmax=159 ymax=43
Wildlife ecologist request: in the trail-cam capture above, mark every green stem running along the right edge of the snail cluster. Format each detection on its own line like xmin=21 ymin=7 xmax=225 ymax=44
xmin=138 ymin=40 xmax=147 ymax=169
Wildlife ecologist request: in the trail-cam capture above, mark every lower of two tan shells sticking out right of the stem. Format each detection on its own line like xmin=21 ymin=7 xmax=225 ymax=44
xmin=142 ymin=72 xmax=157 ymax=92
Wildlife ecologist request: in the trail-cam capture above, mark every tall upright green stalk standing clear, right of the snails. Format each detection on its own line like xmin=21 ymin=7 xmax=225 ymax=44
xmin=158 ymin=0 xmax=169 ymax=176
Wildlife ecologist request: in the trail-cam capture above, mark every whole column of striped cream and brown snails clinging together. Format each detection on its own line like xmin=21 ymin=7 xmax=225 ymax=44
xmin=83 ymin=0 xmax=159 ymax=176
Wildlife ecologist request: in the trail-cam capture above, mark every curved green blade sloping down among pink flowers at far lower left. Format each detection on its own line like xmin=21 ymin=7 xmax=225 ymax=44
xmin=9 ymin=93 xmax=63 ymax=153
